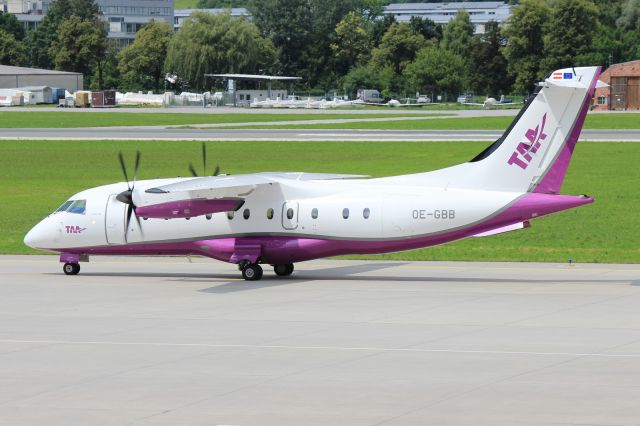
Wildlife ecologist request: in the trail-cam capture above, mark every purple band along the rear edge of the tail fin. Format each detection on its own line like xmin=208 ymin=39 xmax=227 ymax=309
xmin=533 ymin=67 xmax=601 ymax=194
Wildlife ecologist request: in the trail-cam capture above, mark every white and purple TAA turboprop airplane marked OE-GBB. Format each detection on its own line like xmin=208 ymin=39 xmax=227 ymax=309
xmin=24 ymin=67 xmax=600 ymax=280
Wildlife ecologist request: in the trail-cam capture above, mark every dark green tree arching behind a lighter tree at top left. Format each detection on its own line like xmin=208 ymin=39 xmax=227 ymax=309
xmin=26 ymin=0 xmax=100 ymax=68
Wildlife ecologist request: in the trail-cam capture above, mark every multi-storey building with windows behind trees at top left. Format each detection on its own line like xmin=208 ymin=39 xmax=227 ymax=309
xmin=0 ymin=0 xmax=173 ymax=46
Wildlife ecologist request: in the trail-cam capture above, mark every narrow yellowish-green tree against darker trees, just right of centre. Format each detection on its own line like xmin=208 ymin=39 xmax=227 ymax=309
xmin=331 ymin=12 xmax=371 ymax=75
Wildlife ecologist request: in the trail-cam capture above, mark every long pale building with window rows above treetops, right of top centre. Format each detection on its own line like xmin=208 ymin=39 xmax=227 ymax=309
xmin=384 ymin=1 xmax=511 ymax=34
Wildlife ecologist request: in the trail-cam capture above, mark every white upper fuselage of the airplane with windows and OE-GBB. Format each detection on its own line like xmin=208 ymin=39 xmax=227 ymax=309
xmin=25 ymin=178 xmax=522 ymax=250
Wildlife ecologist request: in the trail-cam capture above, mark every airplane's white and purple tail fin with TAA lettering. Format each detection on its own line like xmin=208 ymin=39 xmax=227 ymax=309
xmin=464 ymin=67 xmax=600 ymax=194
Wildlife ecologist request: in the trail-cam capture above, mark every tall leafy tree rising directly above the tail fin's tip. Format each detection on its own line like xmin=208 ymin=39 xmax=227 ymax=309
xmin=542 ymin=0 xmax=598 ymax=73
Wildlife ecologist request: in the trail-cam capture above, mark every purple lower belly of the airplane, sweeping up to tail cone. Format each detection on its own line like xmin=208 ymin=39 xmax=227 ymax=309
xmin=55 ymin=193 xmax=593 ymax=264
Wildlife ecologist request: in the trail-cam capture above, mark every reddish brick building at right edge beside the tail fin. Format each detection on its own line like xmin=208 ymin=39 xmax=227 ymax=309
xmin=593 ymin=60 xmax=640 ymax=111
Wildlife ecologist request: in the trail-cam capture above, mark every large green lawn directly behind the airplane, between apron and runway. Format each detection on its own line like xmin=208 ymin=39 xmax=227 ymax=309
xmin=0 ymin=141 xmax=640 ymax=263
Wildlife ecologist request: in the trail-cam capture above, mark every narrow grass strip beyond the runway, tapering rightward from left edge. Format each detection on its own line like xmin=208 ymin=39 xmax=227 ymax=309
xmin=0 ymin=111 xmax=432 ymax=129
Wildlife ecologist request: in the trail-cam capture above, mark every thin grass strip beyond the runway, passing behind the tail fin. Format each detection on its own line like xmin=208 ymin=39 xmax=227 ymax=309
xmin=232 ymin=113 xmax=640 ymax=130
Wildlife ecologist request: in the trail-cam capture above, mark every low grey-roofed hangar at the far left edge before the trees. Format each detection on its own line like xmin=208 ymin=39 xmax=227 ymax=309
xmin=0 ymin=65 xmax=84 ymax=92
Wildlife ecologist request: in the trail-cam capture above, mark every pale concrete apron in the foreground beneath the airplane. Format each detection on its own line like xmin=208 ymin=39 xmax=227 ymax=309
xmin=0 ymin=256 xmax=640 ymax=425
